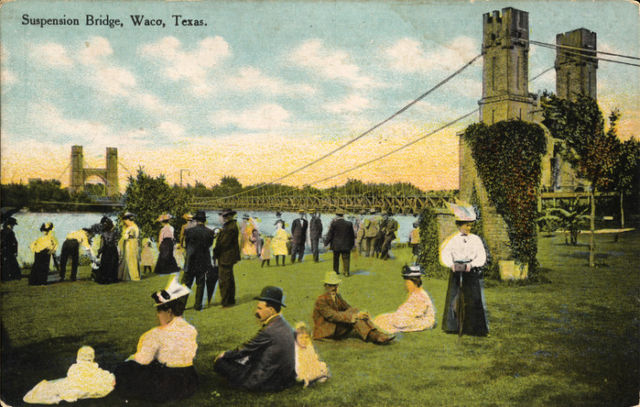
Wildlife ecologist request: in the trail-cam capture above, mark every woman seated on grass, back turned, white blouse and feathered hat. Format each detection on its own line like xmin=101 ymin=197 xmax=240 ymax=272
xmin=115 ymin=277 xmax=198 ymax=402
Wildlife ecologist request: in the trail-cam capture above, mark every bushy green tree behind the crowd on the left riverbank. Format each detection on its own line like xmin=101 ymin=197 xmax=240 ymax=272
xmin=124 ymin=169 xmax=190 ymax=238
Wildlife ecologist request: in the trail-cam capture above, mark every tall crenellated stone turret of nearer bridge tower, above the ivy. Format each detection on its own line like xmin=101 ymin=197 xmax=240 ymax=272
xmin=478 ymin=7 xmax=536 ymax=125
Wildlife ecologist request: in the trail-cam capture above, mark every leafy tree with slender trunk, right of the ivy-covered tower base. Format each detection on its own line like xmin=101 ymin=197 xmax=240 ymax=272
xmin=542 ymin=94 xmax=620 ymax=267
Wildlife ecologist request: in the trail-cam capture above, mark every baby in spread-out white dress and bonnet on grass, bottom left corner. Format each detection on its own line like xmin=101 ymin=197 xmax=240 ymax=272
xmin=23 ymin=346 xmax=116 ymax=404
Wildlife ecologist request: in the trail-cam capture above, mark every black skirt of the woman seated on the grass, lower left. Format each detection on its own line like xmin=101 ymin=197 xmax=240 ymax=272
xmin=115 ymin=360 xmax=198 ymax=402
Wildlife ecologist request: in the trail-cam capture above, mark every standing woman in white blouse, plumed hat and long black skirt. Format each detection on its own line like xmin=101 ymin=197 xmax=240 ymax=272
xmin=440 ymin=204 xmax=489 ymax=336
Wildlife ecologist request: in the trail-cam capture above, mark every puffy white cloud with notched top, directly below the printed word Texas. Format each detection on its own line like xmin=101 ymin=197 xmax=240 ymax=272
xmin=138 ymin=36 xmax=231 ymax=96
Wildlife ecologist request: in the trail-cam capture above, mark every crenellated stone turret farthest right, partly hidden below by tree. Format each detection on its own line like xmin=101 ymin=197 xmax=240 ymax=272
xmin=555 ymin=28 xmax=598 ymax=101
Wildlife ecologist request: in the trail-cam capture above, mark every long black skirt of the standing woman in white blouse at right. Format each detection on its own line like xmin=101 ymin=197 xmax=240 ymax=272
xmin=442 ymin=269 xmax=489 ymax=336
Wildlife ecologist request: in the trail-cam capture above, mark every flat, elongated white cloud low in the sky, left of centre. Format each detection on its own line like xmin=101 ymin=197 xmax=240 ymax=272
xmin=209 ymin=104 xmax=291 ymax=130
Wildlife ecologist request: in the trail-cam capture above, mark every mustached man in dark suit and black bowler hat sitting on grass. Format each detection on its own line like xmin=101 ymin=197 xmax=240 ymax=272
xmin=213 ymin=286 xmax=296 ymax=391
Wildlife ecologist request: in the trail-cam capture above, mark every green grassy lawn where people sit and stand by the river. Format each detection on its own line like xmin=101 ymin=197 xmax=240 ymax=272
xmin=0 ymin=232 xmax=640 ymax=406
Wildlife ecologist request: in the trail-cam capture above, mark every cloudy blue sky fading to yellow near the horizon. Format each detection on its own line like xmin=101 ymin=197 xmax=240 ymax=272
xmin=0 ymin=0 xmax=640 ymax=189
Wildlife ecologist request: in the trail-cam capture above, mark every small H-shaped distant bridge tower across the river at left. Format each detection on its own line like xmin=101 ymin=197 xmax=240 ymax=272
xmin=70 ymin=146 xmax=119 ymax=196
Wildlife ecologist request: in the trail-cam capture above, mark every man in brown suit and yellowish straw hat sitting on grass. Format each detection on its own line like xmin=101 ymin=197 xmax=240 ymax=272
xmin=313 ymin=271 xmax=395 ymax=344
